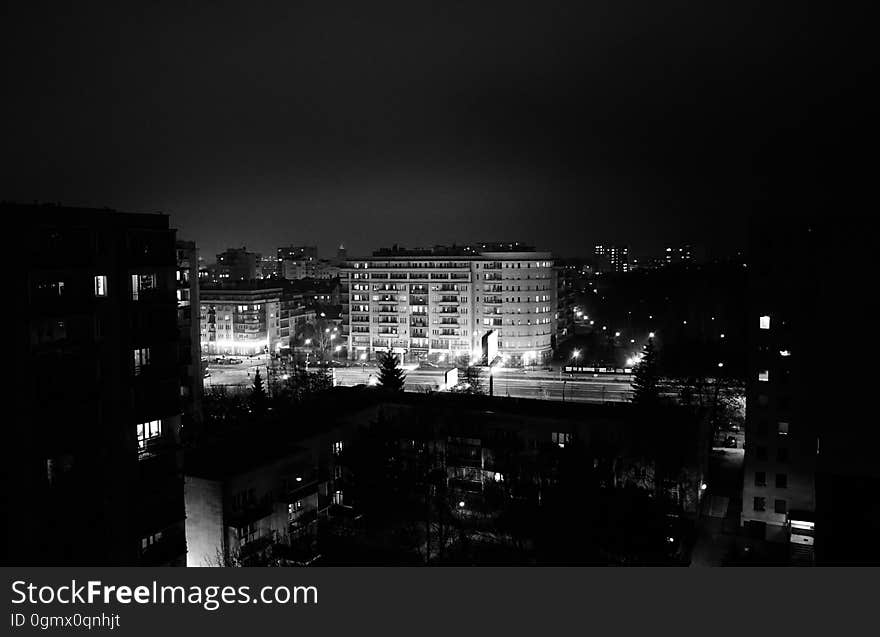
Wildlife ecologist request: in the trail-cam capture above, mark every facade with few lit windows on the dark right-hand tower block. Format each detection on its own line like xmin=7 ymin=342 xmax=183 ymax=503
xmin=742 ymin=214 xmax=822 ymax=557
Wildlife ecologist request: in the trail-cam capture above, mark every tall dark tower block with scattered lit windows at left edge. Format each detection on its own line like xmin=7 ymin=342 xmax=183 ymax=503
xmin=14 ymin=204 xmax=189 ymax=565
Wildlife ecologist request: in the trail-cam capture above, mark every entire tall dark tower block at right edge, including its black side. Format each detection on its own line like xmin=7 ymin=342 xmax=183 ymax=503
xmin=743 ymin=210 xmax=880 ymax=563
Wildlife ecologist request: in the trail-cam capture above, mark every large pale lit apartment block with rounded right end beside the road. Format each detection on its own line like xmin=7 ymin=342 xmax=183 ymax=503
xmin=340 ymin=245 xmax=557 ymax=364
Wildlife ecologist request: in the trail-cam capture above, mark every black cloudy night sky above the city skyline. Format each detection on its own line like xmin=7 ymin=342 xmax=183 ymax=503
xmin=0 ymin=0 xmax=832 ymax=256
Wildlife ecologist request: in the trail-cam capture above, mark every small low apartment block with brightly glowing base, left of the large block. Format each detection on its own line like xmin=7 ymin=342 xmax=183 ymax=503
xmin=200 ymin=287 xmax=283 ymax=356
